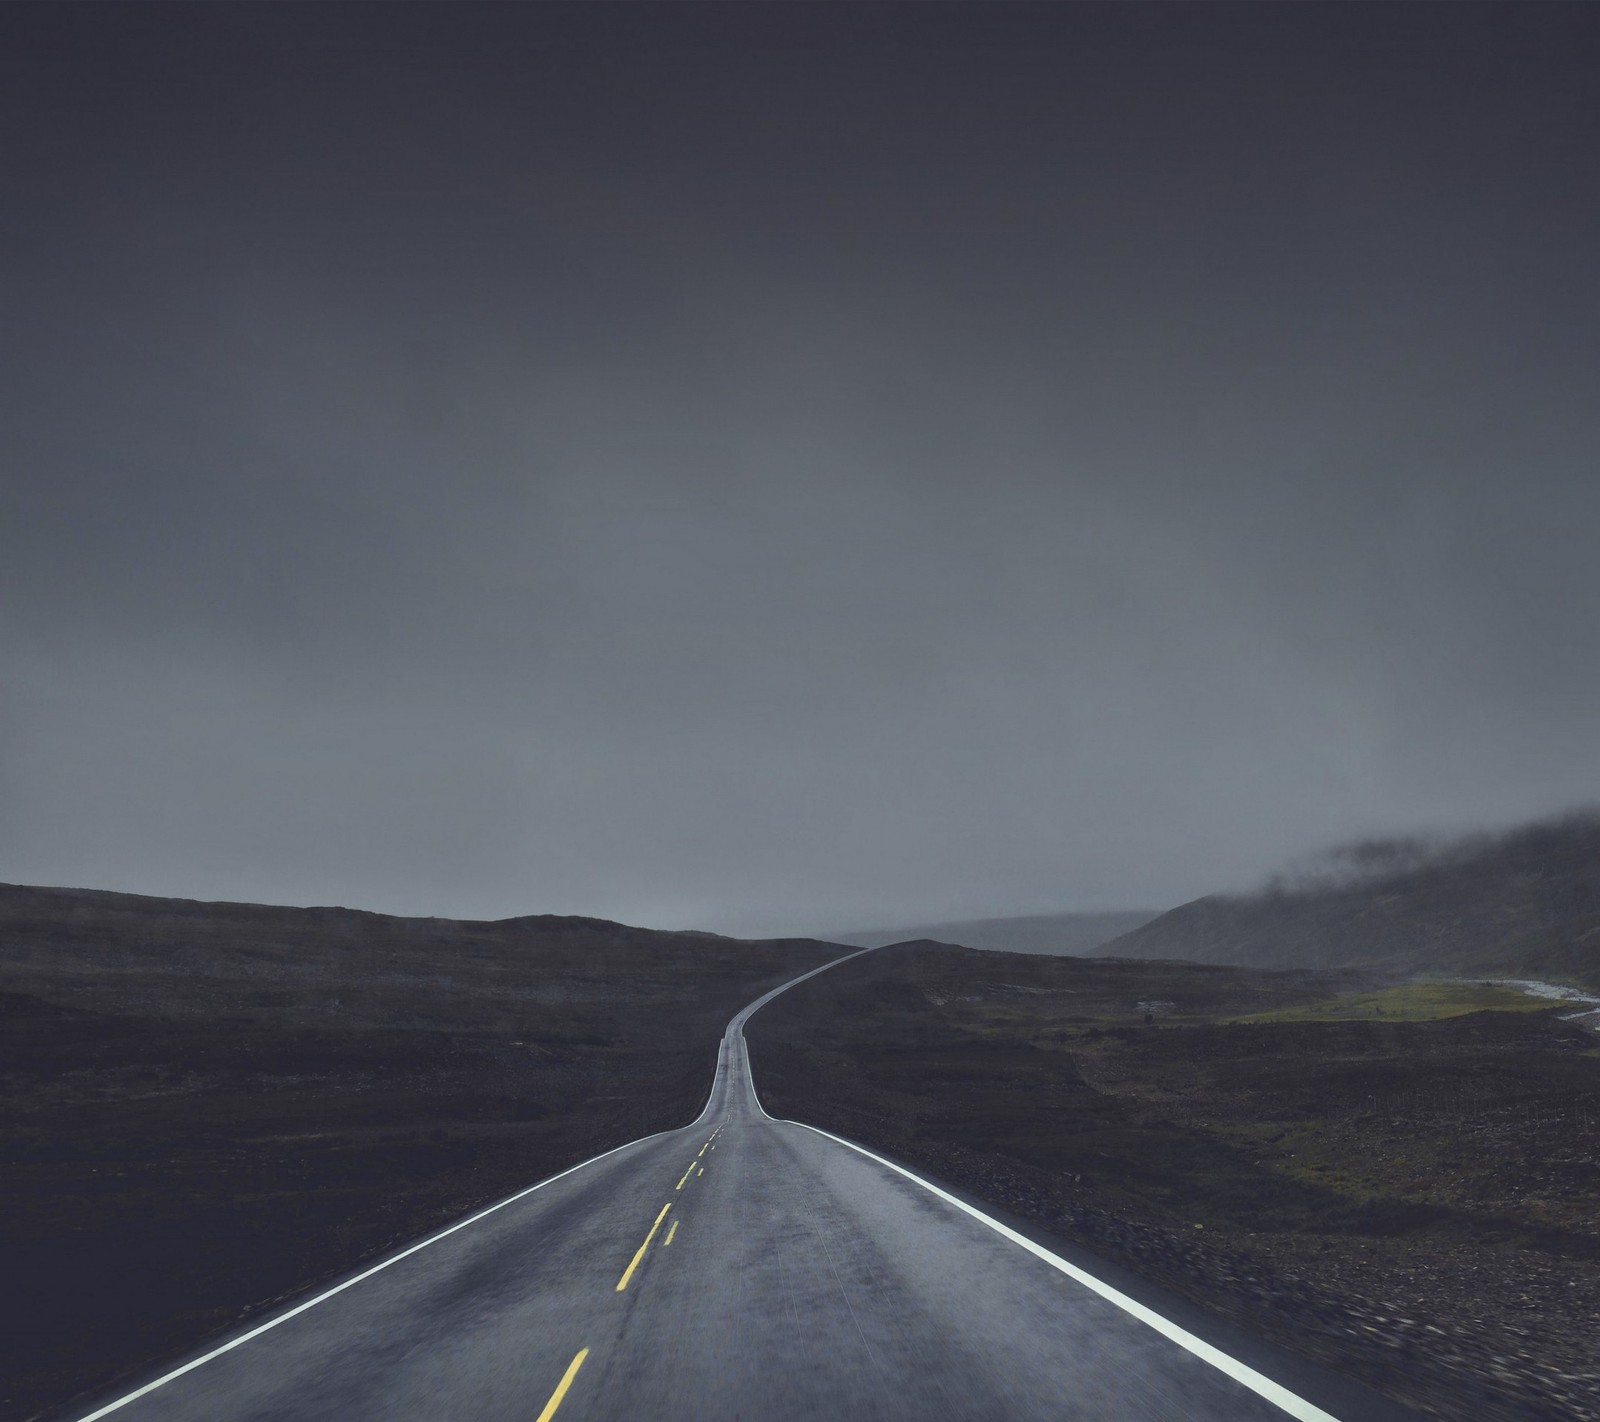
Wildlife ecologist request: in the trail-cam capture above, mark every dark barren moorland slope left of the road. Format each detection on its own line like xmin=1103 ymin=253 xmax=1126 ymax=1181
xmin=0 ymin=886 xmax=838 ymax=1419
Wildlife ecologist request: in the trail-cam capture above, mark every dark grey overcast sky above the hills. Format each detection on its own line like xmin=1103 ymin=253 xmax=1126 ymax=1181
xmin=0 ymin=3 xmax=1600 ymax=933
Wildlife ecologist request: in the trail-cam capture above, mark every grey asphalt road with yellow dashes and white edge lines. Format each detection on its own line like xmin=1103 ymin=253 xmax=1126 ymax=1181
xmin=80 ymin=960 xmax=1410 ymax=1422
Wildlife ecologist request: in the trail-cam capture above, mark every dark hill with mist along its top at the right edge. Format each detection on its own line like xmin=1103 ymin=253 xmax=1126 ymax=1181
xmin=1101 ymin=811 xmax=1600 ymax=987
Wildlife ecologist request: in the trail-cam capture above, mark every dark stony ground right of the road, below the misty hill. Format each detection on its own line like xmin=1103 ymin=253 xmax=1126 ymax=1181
xmin=746 ymin=944 xmax=1600 ymax=1422
